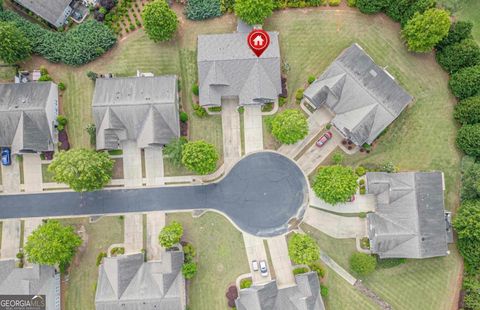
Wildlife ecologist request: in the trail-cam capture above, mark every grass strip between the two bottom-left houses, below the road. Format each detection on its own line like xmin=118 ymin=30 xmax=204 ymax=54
xmin=61 ymin=216 xmax=123 ymax=310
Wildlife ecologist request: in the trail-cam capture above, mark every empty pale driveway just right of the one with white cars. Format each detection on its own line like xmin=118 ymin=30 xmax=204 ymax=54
xmin=267 ymin=236 xmax=296 ymax=288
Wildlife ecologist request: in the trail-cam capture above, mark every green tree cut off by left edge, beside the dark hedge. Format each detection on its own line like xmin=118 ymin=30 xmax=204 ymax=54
xmin=0 ymin=22 xmax=32 ymax=64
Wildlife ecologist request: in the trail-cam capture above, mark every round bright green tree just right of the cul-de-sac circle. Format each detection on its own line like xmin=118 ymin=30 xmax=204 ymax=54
xmin=313 ymin=165 xmax=358 ymax=204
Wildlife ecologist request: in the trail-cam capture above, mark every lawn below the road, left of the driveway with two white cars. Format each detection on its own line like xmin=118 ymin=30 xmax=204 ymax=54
xmin=167 ymin=212 xmax=249 ymax=310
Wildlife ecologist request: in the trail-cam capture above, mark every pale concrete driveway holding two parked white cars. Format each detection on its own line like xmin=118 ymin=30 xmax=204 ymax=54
xmin=243 ymin=233 xmax=272 ymax=284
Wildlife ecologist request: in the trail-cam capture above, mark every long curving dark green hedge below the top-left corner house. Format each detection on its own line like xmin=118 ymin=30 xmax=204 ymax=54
xmin=0 ymin=11 xmax=117 ymax=66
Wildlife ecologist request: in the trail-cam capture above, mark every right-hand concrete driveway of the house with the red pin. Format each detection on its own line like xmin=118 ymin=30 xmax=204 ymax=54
xmin=243 ymin=105 xmax=263 ymax=154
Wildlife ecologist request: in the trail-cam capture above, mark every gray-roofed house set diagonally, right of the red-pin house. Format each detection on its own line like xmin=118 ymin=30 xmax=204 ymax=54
xmin=304 ymin=44 xmax=412 ymax=146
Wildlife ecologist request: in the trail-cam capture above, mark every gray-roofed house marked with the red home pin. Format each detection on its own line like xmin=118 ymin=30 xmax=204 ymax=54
xmin=197 ymin=30 xmax=282 ymax=107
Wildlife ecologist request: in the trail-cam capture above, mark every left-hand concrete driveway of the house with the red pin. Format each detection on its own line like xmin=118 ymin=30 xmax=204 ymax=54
xmin=222 ymin=99 xmax=242 ymax=168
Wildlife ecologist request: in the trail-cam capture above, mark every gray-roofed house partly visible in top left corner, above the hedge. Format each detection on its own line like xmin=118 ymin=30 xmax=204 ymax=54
xmin=14 ymin=0 xmax=72 ymax=28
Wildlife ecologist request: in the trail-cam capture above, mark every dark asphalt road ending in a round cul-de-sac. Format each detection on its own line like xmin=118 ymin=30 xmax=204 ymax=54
xmin=0 ymin=152 xmax=308 ymax=237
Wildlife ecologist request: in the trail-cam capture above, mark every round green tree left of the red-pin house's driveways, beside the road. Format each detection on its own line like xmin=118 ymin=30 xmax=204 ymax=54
xmin=182 ymin=140 xmax=218 ymax=174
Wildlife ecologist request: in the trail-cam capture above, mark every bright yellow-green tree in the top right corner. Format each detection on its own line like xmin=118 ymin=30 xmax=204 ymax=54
xmin=402 ymin=9 xmax=450 ymax=52
